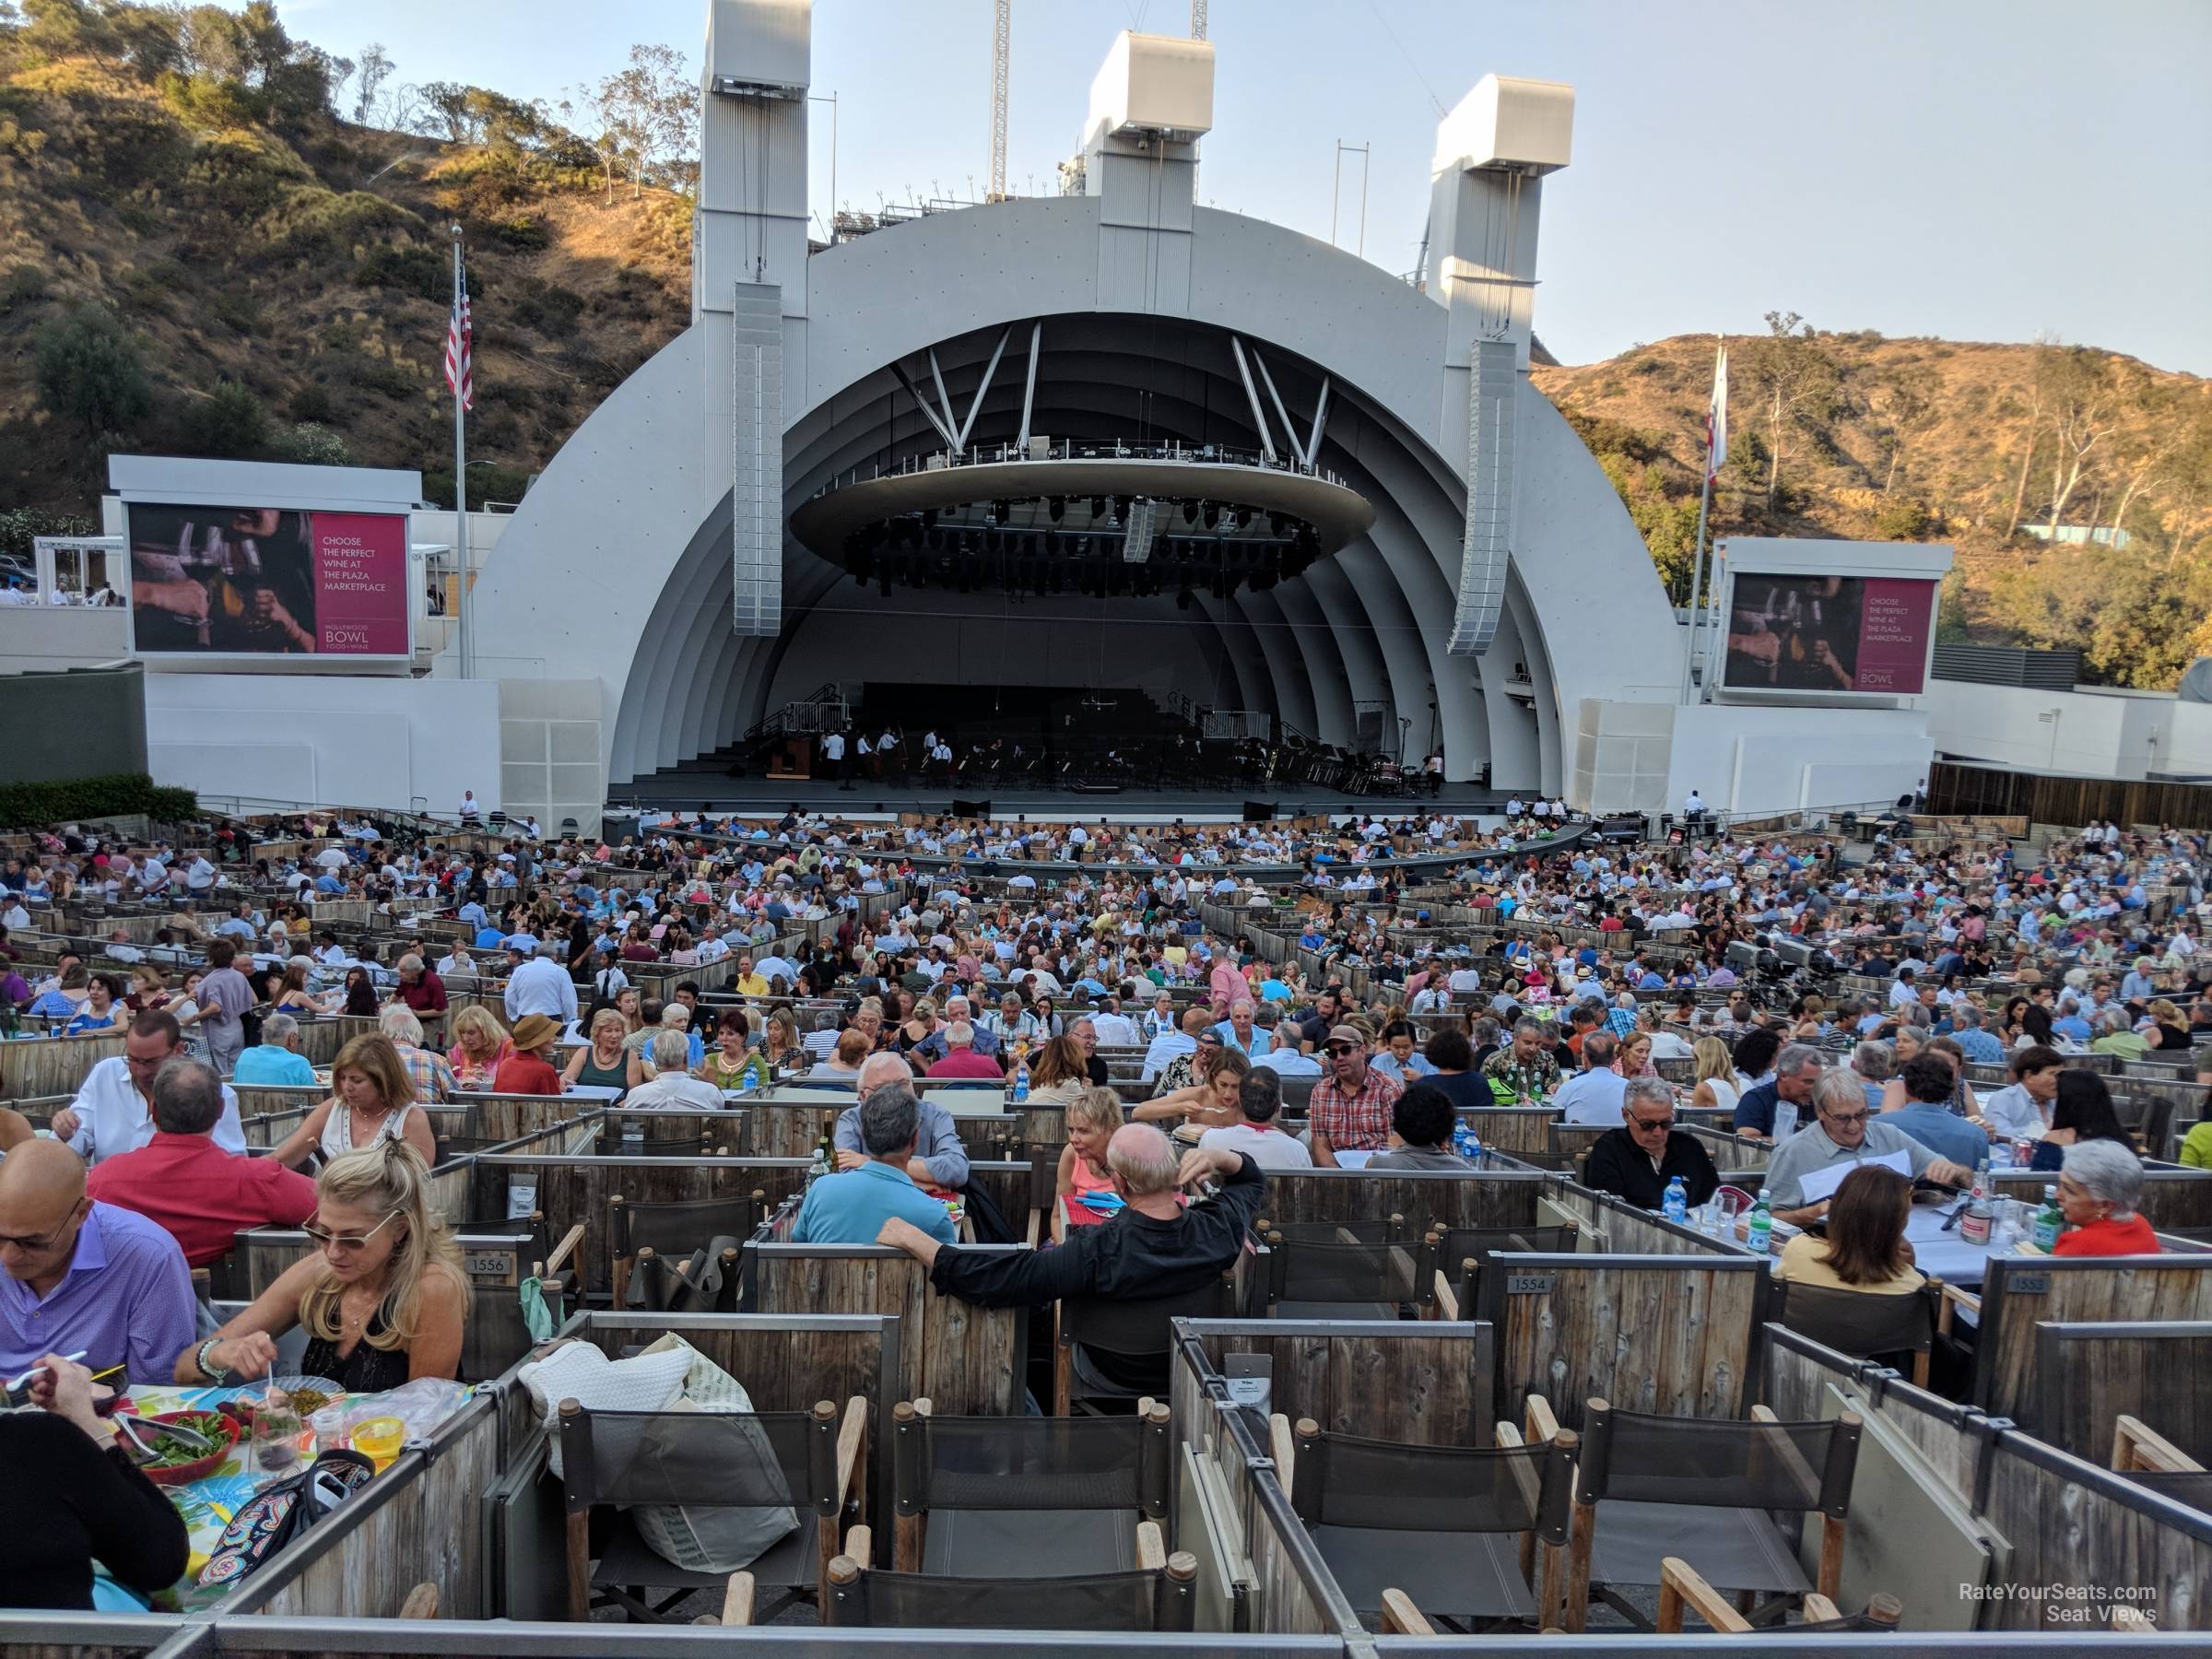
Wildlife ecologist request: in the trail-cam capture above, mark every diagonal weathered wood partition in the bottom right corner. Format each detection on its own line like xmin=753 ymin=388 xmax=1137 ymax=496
xmin=1765 ymin=1329 xmax=2212 ymax=1653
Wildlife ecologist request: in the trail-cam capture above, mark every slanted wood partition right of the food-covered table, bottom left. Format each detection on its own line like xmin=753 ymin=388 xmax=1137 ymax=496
xmin=223 ymin=1392 xmax=502 ymax=1628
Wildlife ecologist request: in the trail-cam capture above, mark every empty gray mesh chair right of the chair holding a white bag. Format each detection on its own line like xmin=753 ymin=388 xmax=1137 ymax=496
xmin=891 ymin=1403 xmax=1171 ymax=1577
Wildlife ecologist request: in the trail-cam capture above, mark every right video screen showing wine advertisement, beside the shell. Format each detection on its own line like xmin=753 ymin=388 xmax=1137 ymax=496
xmin=1721 ymin=571 xmax=1937 ymax=697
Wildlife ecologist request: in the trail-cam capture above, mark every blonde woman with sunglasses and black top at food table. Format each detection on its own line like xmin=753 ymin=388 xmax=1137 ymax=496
xmin=177 ymin=1139 xmax=469 ymax=1394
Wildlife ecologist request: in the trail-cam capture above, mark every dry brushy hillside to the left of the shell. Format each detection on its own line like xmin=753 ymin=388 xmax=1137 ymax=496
xmin=0 ymin=6 xmax=690 ymax=528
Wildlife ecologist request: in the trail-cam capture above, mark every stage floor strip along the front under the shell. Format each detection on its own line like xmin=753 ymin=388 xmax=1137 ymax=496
xmin=608 ymin=768 xmax=1511 ymax=823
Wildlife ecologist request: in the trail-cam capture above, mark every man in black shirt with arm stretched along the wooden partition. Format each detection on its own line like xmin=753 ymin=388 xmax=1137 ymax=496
xmin=876 ymin=1124 xmax=1267 ymax=1398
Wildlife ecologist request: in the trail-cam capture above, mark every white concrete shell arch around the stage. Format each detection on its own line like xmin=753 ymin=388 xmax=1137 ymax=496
xmin=474 ymin=197 xmax=1681 ymax=792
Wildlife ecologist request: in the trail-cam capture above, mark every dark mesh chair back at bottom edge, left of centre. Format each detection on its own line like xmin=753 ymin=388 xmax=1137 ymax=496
xmin=823 ymin=1555 xmax=1196 ymax=1632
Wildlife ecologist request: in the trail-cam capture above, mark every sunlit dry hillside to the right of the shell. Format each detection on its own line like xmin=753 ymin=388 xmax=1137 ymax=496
xmin=1533 ymin=327 xmax=2212 ymax=686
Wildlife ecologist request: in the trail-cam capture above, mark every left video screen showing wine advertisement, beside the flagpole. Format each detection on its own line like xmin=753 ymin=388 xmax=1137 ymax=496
xmin=128 ymin=502 xmax=409 ymax=657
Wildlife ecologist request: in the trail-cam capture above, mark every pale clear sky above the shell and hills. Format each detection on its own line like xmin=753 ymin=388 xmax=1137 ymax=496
xmin=254 ymin=0 xmax=2212 ymax=374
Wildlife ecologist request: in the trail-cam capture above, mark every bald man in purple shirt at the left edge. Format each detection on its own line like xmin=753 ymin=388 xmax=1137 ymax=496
xmin=0 ymin=1141 xmax=197 ymax=1382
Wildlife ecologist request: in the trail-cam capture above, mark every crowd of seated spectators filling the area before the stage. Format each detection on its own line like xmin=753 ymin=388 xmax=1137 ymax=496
xmin=0 ymin=812 xmax=2212 ymax=1610
